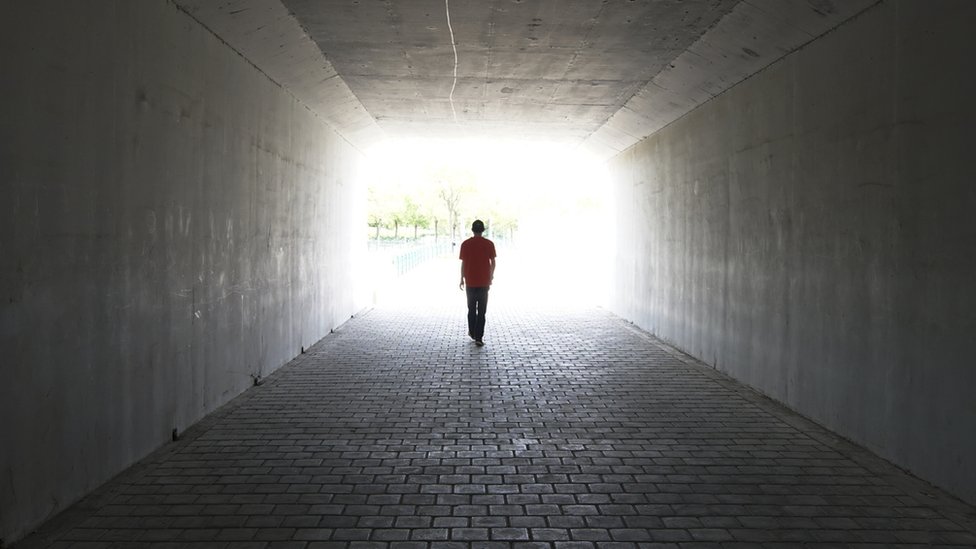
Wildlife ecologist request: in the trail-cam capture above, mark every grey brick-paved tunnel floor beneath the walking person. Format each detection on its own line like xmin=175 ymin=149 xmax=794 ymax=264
xmin=13 ymin=289 xmax=976 ymax=549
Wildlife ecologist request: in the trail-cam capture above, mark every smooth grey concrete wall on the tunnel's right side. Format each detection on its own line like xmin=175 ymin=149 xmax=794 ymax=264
xmin=611 ymin=0 xmax=976 ymax=503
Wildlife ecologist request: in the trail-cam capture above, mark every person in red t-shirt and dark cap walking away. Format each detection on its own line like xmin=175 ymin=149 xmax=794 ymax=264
xmin=458 ymin=219 xmax=495 ymax=347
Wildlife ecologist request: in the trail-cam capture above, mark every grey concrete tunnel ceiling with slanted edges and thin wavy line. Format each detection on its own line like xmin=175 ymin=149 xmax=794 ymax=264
xmin=176 ymin=0 xmax=879 ymax=158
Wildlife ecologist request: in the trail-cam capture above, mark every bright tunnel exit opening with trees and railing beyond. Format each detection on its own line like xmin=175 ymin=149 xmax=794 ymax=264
xmin=363 ymin=138 xmax=613 ymax=307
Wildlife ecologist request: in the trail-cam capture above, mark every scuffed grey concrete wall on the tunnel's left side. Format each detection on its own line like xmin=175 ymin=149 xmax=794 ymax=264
xmin=0 ymin=0 xmax=365 ymax=543
